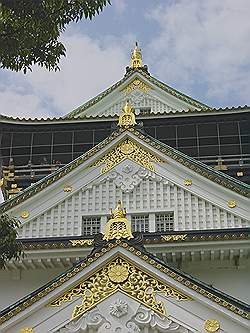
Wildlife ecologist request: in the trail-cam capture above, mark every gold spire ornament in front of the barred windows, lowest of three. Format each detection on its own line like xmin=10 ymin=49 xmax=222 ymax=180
xmin=103 ymin=200 xmax=134 ymax=241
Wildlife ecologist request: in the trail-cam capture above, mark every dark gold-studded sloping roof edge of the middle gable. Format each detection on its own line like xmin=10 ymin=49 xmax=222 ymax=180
xmin=0 ymin=124 xmax=250 ymax=212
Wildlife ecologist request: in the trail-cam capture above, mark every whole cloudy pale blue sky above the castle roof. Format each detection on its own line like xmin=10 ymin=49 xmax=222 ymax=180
xmin=0 ymin=0 xmax=250 ymax=117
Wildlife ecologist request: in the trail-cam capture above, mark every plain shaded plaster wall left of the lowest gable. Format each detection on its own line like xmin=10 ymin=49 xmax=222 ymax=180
xmin=0 ymin=268 xmax=65 ymax=310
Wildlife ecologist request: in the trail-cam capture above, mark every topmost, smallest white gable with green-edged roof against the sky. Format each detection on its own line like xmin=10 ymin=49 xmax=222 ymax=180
xmin=65 ymin=69 xmax=211 ymax=119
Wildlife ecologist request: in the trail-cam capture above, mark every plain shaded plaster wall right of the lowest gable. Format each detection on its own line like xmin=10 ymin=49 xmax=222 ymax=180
xmin=182 ymin=263 xmax=250 ymax=304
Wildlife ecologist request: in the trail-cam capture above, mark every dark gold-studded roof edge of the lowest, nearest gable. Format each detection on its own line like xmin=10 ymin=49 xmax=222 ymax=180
xmin=0 ymin=235 xmax=250 ymax=323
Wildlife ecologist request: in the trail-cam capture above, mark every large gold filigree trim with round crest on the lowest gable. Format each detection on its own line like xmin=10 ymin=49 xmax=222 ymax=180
xmin=50 ymin=257 xmax=189 ymax=319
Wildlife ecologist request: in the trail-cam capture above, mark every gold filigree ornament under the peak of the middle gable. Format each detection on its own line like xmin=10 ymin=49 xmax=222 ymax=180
xmin=91 ymin=139 xmax=163 ymax=173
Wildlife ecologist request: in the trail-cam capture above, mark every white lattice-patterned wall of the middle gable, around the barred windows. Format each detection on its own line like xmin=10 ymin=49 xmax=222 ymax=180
xmin=19 ymin=178 xmax=247 ymax=238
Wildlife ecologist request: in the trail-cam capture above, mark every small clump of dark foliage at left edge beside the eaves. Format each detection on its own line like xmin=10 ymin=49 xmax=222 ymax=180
xmin=0 ymin=214 xmax=23 ymax=269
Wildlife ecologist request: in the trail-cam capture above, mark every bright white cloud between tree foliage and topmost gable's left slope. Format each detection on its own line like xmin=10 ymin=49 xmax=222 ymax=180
xmin=0 ymin=30 xmax=132 ymax=117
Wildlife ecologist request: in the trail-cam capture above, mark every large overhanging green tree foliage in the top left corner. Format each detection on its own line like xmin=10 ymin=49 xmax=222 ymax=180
xmin=0 ymin=0 xmax=110 ymax=73
